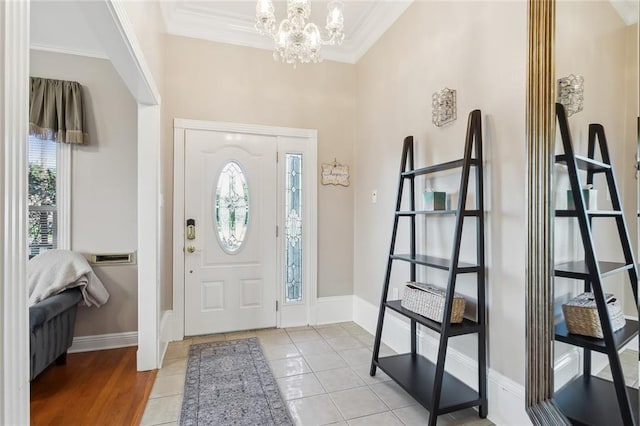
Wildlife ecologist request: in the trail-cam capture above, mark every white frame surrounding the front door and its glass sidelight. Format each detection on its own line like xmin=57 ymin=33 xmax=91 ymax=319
xmin=173 ymin=118 xmax=318 ymax=339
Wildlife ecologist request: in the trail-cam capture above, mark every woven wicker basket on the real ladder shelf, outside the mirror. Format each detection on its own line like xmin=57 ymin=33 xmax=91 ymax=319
xmin=400 ymin=282 xmax=465 ymax=323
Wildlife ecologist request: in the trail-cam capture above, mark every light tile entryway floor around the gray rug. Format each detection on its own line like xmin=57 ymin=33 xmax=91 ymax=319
xmin=141 ymin=322 xmax=492 ymax=426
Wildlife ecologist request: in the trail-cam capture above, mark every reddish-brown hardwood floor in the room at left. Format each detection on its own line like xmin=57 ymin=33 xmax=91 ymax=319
xmin=31 ymin=347 xmax=157 ymax=426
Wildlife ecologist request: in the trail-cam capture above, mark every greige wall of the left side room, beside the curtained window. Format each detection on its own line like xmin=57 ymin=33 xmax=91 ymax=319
xmin=30 ymin=51 xmax=138 ymax=336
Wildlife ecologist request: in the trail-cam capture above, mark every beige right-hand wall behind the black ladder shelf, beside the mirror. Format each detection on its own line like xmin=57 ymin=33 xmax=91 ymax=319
xmin=354 ymin=2 xmax=527 ymax=390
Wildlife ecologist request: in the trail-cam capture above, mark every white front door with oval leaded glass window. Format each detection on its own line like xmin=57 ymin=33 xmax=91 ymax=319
xmin=184 ymin=130 xmax=277 ymax=336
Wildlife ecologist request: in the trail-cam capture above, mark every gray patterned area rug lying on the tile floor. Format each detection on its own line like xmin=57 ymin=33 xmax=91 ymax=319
xmin=180 ymin=337 xmax=293 ymax=426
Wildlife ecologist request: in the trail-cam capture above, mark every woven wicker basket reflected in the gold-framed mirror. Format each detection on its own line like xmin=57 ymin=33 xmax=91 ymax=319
xmin=562 ymin=293 xmax=625 ymax=339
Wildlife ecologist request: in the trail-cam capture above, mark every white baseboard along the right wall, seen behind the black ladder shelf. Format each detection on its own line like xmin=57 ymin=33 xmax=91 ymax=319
xmin=353 ymin=296 xmax=531 ymax=425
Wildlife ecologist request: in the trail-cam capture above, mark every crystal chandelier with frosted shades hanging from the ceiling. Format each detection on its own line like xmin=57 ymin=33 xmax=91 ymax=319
xmin=256 ymin=0 xmax=344 ymax=64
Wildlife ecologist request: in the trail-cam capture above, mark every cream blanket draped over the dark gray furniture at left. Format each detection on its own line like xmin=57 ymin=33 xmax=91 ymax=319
xmin=27 ymin=250 xmax=109 ymax=306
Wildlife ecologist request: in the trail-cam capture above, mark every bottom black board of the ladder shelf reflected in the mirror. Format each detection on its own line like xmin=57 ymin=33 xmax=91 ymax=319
xmin=553 ymin=376 xmax=640 ymax=426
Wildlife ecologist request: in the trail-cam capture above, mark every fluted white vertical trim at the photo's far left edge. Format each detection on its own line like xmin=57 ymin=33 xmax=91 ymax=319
xmin=0 ymin=1 xmax=30 ymax=425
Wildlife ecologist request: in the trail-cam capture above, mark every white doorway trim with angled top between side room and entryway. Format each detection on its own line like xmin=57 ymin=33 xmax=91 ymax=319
xmin=78 ymin=0 xmax=162 ymax=371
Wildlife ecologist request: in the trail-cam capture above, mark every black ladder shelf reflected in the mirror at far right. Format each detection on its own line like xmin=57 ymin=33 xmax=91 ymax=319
xmin=554 ymin=104 xmax=640 ymax=426
